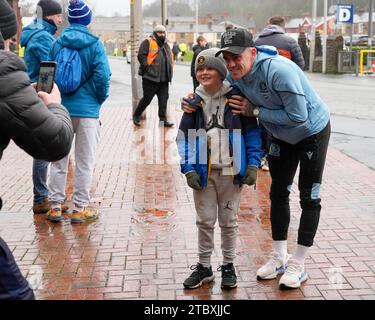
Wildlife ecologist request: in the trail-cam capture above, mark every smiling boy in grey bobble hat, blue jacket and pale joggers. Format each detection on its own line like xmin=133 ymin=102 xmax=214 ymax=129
xmin=177 ymin=48 xmax=261 ymax=289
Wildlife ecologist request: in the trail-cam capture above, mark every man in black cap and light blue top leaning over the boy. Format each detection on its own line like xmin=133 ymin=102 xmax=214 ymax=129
xmin=184 ymin=29 xmax=331 ymax=288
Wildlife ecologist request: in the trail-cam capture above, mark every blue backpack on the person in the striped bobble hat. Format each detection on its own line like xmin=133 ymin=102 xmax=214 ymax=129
xmin=55 ymin=47 xmax=82 ymax=95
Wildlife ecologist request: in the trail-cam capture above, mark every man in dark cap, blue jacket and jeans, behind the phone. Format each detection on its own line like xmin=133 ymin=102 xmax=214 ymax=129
xmin=20 ymin=0 xmax=62 ymax=214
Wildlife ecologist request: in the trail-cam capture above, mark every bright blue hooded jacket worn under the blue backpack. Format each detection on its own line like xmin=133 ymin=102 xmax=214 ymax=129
xmin=50 ymin=24 xmax=111 ymax=118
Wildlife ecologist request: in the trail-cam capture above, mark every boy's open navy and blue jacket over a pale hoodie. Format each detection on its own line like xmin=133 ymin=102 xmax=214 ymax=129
xmin=176 ymin=89 xmax=262 ymax=188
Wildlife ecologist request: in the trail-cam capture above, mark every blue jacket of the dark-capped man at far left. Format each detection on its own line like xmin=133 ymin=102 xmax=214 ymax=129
xmin=20 ymin=19 xmax=57 ymax=82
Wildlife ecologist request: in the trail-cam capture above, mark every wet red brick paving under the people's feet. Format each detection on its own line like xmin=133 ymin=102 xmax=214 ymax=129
xmin=0 ymin=105 xmax=375 ymax=300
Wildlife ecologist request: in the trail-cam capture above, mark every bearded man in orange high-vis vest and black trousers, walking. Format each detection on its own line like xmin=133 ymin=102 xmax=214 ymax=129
xmin=133 ymin=25 xmax=173 ymax=127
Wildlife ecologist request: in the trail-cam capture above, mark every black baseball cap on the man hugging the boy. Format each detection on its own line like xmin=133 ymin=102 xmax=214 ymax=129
xmin=216 ymin=28 xmax=254 ymax=57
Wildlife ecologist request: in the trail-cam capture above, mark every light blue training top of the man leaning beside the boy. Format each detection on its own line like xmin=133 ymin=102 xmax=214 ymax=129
xmin=227 ymin=46 xmax=329 ymax=144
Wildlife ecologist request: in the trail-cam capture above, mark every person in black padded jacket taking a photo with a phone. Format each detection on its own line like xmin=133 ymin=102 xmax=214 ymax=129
xmin=0 ymin=0 xmax=73 ymax=300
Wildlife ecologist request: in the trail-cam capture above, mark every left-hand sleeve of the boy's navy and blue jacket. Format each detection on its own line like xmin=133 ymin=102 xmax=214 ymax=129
xmin=176 ymin=112 xmax=196 ymax=174
